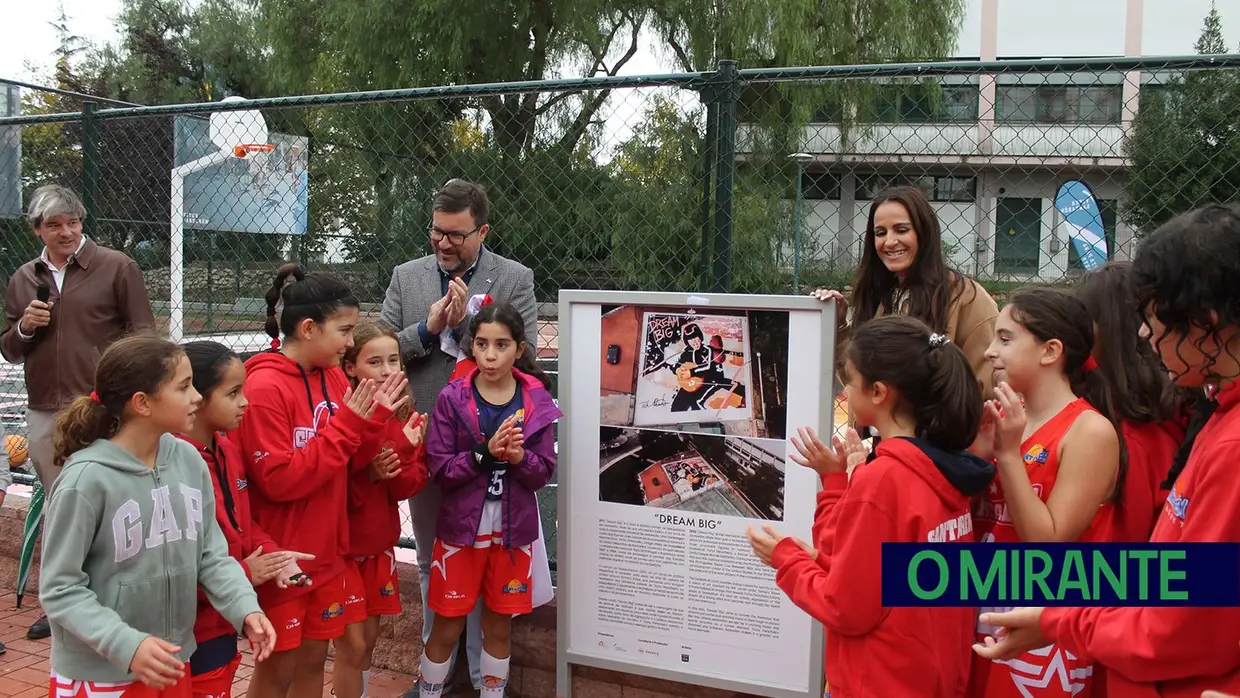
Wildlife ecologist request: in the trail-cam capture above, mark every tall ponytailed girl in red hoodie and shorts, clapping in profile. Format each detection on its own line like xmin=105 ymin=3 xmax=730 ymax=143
xmin=237 ymin=263 xmax=407 ymax=698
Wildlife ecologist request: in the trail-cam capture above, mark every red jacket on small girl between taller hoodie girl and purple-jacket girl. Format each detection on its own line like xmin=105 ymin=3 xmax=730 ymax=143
xmin=348 ymin=415 xmax=429 ymax=558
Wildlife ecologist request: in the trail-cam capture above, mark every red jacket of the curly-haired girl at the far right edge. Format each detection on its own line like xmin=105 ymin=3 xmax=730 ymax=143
xmin=1042 ymin=384 xmax=1240 ymax=698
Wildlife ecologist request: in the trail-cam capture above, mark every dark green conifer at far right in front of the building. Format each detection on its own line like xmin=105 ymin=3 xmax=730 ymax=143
xmin=1122 ymin=6 xmax=1240 ymax=236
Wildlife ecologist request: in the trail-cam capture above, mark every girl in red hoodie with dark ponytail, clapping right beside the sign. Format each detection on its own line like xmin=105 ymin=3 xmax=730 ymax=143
xmin=749 ymin=315 xmax=994 ymax=698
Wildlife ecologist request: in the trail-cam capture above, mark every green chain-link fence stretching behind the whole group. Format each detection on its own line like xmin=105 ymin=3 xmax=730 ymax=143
xmin=0 ymin=55 xmax=1240 ymax=575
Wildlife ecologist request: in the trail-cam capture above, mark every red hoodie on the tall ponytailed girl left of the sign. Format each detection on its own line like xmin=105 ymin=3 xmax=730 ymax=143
xmin=234 ymin=352 xmax=392 ymax=607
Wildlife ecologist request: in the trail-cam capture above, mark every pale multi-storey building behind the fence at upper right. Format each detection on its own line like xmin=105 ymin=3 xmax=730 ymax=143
xmin=794 ymin=0 xmax=1240 ymax=281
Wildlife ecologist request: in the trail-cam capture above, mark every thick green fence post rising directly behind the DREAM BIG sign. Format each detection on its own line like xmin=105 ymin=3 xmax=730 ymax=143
xmin=712 ymin=61 xmax=740 ymax=294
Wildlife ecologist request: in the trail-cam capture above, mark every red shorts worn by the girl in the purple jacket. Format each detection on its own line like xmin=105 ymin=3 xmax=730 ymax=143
xmin=427 ymin=538 xmax=533 ymax=617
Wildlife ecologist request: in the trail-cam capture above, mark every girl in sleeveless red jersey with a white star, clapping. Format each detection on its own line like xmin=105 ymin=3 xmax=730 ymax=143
xmin=971 ymin=288 xmax=1123 ymax=698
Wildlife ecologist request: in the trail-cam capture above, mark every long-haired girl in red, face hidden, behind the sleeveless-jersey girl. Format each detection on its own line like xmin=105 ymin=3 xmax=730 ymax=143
xmin=1076 ymin=262 xmax=1188 ymax=543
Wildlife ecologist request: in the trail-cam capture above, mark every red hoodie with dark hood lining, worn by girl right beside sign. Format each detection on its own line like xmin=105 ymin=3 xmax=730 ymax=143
xmin=771 ymin=439 xmax=994 ymax=698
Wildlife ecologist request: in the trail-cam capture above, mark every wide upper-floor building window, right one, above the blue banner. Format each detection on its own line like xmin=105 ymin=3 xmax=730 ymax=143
xmin=996 ymin=84 xmax=1123 ymax=124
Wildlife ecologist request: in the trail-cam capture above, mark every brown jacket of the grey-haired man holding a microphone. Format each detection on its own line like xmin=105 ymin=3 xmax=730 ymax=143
xmin=0 ymin=238 xmax=155 ymax=410
